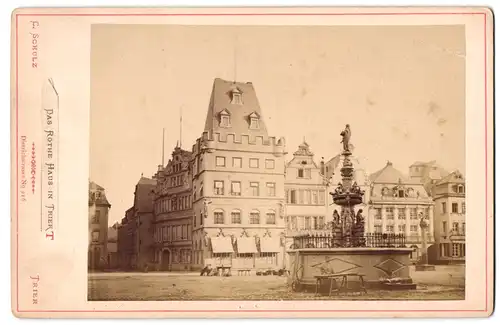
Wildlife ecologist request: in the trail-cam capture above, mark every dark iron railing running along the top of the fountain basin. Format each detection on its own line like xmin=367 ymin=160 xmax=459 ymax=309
xmin=290 ymin=233 xmax=406 ymax=249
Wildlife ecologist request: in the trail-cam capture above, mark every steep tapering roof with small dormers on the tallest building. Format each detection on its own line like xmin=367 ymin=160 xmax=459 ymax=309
xmin=204 ymin=78 xmax=268 ymax=137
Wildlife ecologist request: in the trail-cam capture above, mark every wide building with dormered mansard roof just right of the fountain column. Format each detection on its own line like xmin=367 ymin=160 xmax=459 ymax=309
xmin=365 ymin=162 xmax=434 ymax=261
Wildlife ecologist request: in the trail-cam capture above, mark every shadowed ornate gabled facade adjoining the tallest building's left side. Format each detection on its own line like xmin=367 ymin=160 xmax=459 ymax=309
xmin=154 ymin=146 xmax=193 ymax=271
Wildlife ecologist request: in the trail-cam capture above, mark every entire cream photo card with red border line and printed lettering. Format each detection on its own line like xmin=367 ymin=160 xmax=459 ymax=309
xmin=14 ymin=8 xmax=493 ymax=317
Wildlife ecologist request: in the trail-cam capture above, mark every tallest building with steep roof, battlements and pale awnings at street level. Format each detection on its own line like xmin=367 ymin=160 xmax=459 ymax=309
xmin=191 ymin=79 xmax=285 ymax=270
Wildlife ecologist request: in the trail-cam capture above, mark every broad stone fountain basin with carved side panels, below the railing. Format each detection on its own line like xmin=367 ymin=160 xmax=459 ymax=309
xmin=288 ymin=247 xmax=414 ymax=290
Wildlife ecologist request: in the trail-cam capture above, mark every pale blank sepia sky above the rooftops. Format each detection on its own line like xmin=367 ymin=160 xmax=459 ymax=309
xmin=90 ymin=25 xmax=465 ymax=224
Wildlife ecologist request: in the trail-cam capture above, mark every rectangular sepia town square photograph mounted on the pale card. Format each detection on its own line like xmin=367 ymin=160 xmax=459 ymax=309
xmin=86 ymin=23 xmax=468 ymax=301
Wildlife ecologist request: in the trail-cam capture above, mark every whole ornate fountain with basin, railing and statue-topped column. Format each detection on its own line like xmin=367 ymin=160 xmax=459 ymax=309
xmin=288 ymin=124 xmax=415 ymax=290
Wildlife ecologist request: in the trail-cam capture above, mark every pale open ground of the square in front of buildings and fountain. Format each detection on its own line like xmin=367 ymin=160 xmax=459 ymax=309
xmin=88 ymin=266 xmax=465 ymax=300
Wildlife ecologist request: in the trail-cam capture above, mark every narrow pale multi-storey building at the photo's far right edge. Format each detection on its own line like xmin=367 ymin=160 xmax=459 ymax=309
xmin=429 ymin=171 xmax=466 ymax=264
